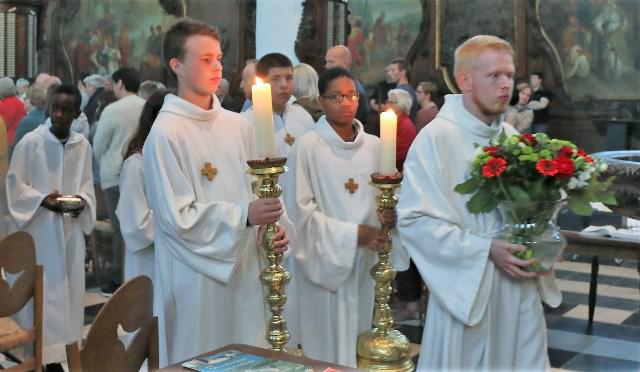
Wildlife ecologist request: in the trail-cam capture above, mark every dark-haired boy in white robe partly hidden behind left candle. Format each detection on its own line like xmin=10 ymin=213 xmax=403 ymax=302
xmin=242 ymin=53 xmax=314 ymax=157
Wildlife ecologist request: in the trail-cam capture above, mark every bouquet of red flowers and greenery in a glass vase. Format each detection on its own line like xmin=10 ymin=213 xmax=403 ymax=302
xmin=455 ymin=132 xmax=616 ymax=271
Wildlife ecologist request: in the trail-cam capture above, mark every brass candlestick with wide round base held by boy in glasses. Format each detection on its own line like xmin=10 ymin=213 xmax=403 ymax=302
xmin=357 ymin=172 xmax=413 ymax=371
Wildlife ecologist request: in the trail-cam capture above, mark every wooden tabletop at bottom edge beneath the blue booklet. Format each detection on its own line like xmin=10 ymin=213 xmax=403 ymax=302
xmin=160 ymin=344 xmax=362 ymax=372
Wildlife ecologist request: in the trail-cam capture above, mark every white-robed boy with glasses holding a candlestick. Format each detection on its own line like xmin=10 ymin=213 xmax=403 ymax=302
xmin=284 ymin=67 xmax=408 ymax=367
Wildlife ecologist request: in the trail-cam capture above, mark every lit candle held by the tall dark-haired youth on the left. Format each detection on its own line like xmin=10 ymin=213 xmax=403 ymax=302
xmin=251 ymin=78 xmax=276 ymax=158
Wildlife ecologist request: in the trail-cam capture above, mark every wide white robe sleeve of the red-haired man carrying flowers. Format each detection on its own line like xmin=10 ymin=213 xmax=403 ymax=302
xmin=398 ymin=133 xmax=494 ymax=325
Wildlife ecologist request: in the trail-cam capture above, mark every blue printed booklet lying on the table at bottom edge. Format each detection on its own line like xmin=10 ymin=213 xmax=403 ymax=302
xmin=182 ymin=350 xmax=313 ymax=372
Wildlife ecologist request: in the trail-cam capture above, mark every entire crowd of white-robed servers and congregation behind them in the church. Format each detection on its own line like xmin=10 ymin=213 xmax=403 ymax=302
xmin=0 ymin=19 xmax=550 ymax=371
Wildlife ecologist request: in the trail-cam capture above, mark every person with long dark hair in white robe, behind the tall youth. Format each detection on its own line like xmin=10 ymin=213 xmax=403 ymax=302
xmin=116 ymin=90 xmax=169 ymax=281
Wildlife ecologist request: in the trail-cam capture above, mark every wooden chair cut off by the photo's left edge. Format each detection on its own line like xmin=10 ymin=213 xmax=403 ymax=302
xmin=0 ymin=231 xmax=43 ymax=372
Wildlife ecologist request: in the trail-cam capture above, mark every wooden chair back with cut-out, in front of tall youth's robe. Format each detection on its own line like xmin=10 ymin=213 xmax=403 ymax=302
xmin=67 ymin=276 xmax=158 ymax=372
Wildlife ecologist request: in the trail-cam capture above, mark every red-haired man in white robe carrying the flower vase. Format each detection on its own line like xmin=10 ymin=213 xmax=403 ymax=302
xmin=398 ymin=35 xmax=561 ymax=371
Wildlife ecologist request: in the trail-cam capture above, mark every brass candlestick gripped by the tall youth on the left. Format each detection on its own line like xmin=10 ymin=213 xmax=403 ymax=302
xmin=247 ymin=158 xmax=291 ymax=351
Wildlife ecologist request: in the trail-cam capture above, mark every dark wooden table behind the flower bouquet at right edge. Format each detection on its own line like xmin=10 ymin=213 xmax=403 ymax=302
xmin=562 ymin=230 xmax=640 ymax=333
